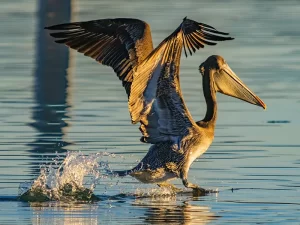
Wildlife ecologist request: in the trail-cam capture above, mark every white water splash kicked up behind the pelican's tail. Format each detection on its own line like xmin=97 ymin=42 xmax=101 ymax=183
xmin=19 ymin=152 xmax=111 ymax=202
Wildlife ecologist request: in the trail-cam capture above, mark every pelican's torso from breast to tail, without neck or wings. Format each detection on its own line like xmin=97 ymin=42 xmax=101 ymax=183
xmin=127 ymin=130 xmax=214 ymax=184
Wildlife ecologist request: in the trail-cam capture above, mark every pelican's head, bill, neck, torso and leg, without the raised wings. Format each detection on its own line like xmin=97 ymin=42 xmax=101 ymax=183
xmin=126 ymin=55 xmax=266 ymax=191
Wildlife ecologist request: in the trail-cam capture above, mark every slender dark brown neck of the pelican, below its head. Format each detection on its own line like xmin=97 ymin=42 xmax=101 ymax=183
xmin=202 ymin=70 xmax=217 ymax=128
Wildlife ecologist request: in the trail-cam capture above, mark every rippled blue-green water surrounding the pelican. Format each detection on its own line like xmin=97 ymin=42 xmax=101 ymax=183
xmin=0 ymin=0 xmax=300 ymax=224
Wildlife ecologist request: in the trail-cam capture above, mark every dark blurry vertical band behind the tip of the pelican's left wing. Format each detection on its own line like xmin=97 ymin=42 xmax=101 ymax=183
xmin=29 ymin=0 xmax=72 ymax=173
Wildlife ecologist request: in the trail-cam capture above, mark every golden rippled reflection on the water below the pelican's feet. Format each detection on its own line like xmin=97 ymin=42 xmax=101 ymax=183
xmin=134 ymin=197 xmax=218 ymax=225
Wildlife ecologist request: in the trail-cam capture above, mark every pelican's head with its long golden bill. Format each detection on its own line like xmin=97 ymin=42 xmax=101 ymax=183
xmin=199 ymin=55 xmax=267 ymax=109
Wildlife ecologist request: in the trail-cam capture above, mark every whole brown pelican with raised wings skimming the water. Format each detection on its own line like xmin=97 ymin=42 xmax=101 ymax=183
xmin=46 ymin=18 xmax=265 ymax=193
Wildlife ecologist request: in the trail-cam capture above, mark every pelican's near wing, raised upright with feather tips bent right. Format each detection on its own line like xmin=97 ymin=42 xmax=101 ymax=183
xmin=129 ymin=19 xmax=233 ymax=144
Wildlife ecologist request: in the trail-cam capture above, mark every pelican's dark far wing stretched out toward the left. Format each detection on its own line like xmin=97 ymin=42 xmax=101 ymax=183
xmin=45 ymin=18 xmax=153 ymax=96
